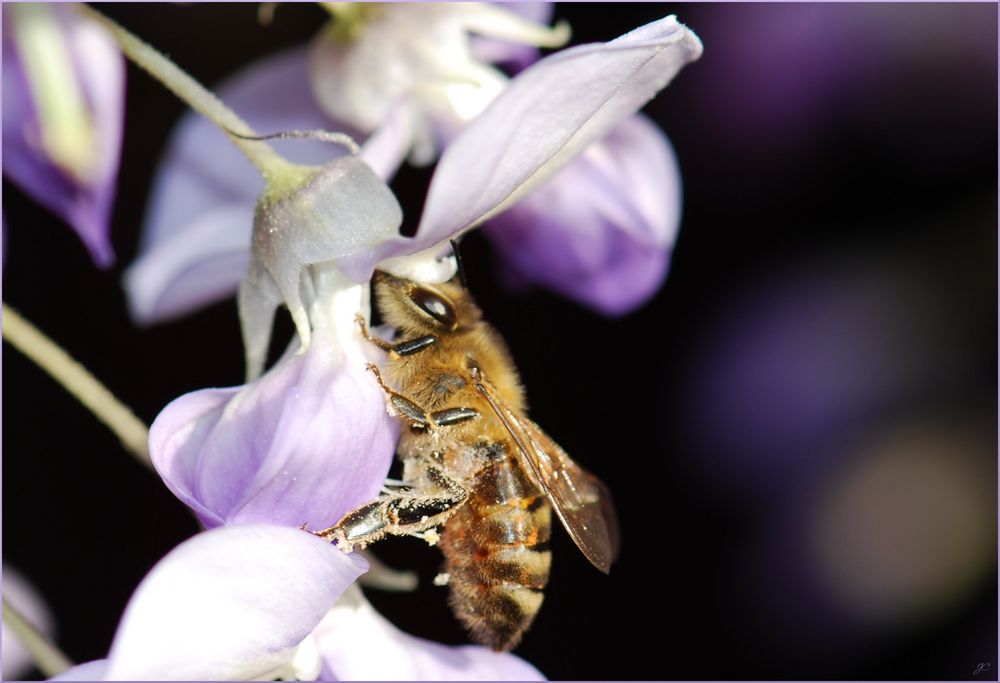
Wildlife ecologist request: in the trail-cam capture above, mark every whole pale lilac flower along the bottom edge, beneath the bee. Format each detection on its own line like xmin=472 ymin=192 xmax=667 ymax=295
xmin=49 ymin=524 xmax=541 ymax=680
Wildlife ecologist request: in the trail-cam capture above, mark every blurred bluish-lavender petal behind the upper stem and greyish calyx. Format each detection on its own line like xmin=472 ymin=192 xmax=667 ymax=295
xmin=125 ymin=49 xmax=343 ymax=323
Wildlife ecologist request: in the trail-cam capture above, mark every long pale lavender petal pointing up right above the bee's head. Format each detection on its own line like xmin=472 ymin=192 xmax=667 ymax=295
xmin=410 ymin=17 xmax=701 ymax=255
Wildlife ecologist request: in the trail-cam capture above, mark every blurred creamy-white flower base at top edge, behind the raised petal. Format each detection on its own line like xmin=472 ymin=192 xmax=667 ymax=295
xmin=310 ymin=2 xmax=569 ymax=164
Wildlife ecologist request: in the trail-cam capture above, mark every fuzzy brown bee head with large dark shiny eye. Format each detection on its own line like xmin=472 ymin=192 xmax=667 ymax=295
xmin=372 ymin=270 xmax=482 ymax=334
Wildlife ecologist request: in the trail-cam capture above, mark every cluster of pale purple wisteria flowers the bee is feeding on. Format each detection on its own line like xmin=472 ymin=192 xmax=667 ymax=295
xmin=4 ymin=3 xmax=701 ymax=679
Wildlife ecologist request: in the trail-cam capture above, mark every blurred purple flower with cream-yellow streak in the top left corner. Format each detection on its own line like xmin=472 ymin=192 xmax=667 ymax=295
xmin=3 ymin=3 xmax=125 ymax=267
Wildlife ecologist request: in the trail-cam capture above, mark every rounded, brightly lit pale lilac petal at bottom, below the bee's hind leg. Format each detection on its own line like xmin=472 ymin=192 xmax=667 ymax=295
xmin=106 ymin=525 xmax=367 ymax=680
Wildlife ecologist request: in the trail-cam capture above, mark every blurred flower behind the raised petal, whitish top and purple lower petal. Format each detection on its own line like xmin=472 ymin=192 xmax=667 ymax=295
xmin=312 ymin=5 xmax=696 ymax=314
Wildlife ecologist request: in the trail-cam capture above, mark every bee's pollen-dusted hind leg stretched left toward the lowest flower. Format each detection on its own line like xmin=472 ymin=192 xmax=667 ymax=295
xmin=311 ymin=464 xmax=469 ymax=552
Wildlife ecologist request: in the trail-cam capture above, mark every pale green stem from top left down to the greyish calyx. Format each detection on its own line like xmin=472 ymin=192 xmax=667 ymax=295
xmin=80 ymin=5 xmax=292 ymax=181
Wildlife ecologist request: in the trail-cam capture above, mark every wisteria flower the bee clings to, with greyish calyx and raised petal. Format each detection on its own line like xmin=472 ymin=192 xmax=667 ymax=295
xmin=141 ymin=17 xmax=700 ymax=677
